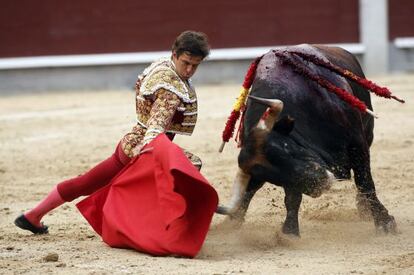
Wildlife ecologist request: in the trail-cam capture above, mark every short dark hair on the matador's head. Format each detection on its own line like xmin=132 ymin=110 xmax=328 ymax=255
xmin=172 ymin=31 xmax=210 ymax=59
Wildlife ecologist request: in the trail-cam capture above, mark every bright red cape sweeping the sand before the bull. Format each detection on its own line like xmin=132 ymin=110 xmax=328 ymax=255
xmin=77 ymin=134 xmax=218 ymax=257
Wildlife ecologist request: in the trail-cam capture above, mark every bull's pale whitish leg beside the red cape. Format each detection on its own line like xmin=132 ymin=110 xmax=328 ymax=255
xmin=216 ymin=169 xmax=264 ymax=222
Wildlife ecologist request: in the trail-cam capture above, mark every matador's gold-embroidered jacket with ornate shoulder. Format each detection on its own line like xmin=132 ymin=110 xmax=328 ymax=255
xmin=121 ymin=58 xmax=197 ymax=162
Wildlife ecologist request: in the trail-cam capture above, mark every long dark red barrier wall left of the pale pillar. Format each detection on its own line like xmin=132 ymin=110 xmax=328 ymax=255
xmin=0 ymin=0 xmax=359 ymax=57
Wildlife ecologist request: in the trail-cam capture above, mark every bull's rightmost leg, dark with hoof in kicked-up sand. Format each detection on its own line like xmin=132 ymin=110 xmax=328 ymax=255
xmin=352 ymin=149 xmax=397 ymax=233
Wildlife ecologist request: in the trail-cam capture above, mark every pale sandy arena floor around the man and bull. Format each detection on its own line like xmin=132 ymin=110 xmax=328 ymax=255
xmin=0 ymin=75 xmax=414 ymax=274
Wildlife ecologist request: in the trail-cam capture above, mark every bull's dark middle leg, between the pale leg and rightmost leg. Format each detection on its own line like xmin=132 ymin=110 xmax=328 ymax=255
xmin=282 ymin=188 xmax=302 ymax=237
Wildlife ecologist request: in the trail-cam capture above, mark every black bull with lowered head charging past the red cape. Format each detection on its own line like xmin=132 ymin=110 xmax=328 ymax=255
xmin=217 ymin=45 xmax=396 ymax=235
